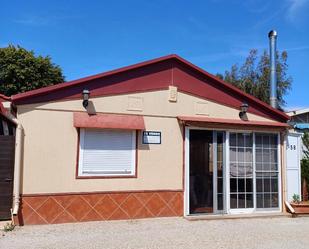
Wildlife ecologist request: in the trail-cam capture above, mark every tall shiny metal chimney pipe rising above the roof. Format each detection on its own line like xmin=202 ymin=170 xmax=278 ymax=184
xmin=268 ymin=30 xmax=278 ymax=108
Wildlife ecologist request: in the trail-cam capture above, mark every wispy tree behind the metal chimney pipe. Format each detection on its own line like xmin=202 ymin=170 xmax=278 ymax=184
xmin=217 ymin=49 xmax=292 ymax=108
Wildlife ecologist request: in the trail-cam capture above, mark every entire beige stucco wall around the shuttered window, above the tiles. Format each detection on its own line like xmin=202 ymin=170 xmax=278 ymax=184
xmin=18 ymin=90 xmax=276 ymax=194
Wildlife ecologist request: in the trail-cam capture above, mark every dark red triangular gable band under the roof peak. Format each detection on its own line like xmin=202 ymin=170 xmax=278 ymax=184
xmin=13 ymin=59 xmax=286 ymax=122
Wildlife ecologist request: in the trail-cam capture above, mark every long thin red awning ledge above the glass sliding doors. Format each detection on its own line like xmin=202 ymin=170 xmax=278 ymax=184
xmin=177 ymin=116 xmax=290 ymax=128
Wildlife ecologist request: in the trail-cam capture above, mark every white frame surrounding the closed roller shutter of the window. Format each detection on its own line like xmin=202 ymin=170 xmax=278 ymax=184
xmin=78 ymin=128 xmax=136 ymax=178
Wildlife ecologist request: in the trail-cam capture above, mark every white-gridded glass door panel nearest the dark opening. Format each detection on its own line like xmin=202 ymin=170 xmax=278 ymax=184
xmin=230 ymin=133 xmax=254 ymax=209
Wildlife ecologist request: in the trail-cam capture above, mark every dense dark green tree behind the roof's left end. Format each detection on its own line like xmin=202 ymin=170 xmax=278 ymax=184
xmin=0 ymin=45 xmax=64 ymax=96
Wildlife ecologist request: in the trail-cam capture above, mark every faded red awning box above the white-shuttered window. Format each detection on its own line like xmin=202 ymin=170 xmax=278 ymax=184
xmin=73 ymin=112 xmax=145 ymax=130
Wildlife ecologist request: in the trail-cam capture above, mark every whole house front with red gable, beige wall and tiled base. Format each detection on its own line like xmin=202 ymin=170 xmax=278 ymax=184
xmin=7 ymin=55 xmax=288 ymax=224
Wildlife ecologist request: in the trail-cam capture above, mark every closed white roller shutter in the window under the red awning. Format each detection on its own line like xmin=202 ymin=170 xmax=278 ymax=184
xmin=79 ymin=129 xmax=135 ymax=176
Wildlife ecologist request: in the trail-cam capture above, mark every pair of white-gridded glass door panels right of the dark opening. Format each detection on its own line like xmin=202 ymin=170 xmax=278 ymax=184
xmin=228 ymin=132 xmax=280 ymax=213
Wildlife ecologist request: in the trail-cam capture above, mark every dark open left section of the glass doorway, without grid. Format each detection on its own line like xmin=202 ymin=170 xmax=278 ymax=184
xmin=189 ymin=129 xmax=226 ymax=214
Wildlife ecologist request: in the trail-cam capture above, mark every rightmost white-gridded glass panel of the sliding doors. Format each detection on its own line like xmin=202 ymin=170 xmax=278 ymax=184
xmin=255 ymin=133 xmax=279 ymax=209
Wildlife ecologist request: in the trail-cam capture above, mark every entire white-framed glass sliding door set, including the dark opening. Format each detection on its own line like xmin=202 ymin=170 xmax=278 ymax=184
xmin=186 ymin=128 xmax=281 ymax=214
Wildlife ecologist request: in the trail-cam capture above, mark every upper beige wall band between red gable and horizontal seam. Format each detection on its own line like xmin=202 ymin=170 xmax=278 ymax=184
xmin=18 ymin=90 xmax=272 ymax=121
